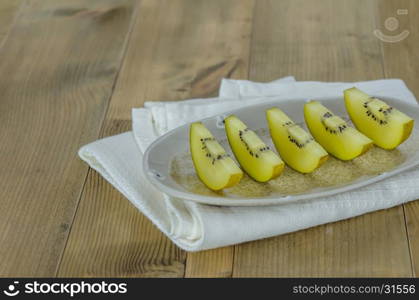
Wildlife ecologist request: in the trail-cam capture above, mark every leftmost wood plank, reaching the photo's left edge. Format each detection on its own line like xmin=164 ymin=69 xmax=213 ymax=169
xmin=0 ymin=0 xmax=133 ymax=277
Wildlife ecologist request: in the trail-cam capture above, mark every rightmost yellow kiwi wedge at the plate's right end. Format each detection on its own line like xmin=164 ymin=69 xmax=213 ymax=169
xmin=344 ymin=87 xmax=414 ymax=150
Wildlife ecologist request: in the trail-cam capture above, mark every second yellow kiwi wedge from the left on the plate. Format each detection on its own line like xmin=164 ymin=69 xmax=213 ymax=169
xmin=224 ymin=115 xmax=284 ymax=182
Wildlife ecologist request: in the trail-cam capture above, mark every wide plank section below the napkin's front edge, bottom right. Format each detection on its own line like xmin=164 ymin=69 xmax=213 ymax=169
xmin=233 ymin=207 xmax=411 ymax=277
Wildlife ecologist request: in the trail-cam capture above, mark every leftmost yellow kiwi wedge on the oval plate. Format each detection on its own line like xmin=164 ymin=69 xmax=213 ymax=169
xmin=189 ymin=122 xmax=243 ymax=191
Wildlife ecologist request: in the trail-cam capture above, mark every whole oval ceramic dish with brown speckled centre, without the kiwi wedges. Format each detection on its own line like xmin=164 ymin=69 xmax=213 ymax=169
xmin=143 ymin=98 xmax=419 ymax=206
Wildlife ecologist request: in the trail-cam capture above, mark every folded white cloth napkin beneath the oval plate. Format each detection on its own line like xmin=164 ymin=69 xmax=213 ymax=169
xmin=79 ymin=77 xmax=419 ymax=251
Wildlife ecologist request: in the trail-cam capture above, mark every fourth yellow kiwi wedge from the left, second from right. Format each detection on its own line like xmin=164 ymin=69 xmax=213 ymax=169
xmin=304 ymin=101 xmax=373 ymax=160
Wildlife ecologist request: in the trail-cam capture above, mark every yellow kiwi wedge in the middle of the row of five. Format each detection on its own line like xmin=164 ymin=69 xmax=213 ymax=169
xmin=266 ymin=107 xmax=329 ymax=173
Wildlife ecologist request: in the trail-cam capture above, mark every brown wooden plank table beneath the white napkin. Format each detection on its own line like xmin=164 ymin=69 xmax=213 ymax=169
xmin=0 ymin=0 xmax=419 ymax=277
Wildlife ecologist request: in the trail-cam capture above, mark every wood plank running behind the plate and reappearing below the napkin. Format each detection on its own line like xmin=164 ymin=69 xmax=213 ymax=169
xmin=233 ymin=0 xmax=411 ymax=277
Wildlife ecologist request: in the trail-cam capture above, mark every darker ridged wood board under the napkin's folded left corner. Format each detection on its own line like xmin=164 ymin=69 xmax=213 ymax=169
xmin=58 ymin=120 xmax=184 ymax=277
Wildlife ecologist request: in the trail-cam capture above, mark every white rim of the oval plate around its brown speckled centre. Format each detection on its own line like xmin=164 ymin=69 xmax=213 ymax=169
xmin=143 ymin=97 xmax=419 ymax=206
